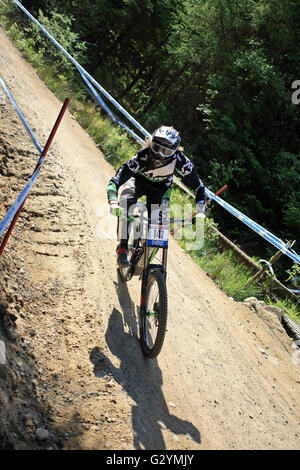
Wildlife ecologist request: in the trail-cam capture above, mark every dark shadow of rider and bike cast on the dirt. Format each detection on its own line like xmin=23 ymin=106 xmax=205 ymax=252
xmin=90 ymin=280 xmax=201 ymax=450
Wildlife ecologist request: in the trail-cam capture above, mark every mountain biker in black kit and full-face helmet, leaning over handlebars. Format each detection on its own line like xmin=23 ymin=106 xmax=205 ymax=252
xmin=107 ymin=126 xmax=206 ymax=268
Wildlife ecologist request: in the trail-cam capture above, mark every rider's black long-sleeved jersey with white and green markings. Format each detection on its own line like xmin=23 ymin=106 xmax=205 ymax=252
xmin=107 ymin=147 xmax=205 ymax=201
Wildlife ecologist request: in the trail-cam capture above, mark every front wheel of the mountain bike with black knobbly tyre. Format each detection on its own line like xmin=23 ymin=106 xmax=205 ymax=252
xmin=141 ymin=270 xmax=168 ymax=359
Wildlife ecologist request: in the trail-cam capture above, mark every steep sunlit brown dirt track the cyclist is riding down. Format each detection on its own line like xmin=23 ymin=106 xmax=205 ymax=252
xmin=0 ymin=26 xmax=300 ymax=450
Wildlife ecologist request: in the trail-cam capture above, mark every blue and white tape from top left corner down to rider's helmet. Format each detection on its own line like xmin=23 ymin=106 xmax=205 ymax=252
xmin=14 ymin=0 xmax=151 ymax=142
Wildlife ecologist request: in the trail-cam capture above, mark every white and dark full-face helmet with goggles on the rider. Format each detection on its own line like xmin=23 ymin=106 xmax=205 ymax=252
xmin=150 ymin=126 xmax=181 ymax=165
